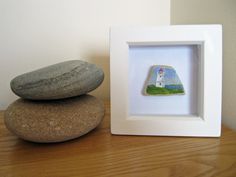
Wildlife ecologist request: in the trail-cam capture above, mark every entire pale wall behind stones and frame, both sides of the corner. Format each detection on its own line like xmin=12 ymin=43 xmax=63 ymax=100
xmin=0 ymin=0 xmax=236 ymax=129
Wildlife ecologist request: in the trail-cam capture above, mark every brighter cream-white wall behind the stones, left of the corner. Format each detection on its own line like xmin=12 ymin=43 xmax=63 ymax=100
xmin=0 ymin=0 xmax=170 ymax=109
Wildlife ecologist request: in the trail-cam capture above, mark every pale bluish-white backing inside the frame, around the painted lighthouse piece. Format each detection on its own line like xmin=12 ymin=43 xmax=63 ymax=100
xmin=129 ymin=45 xmax=200 ymax=115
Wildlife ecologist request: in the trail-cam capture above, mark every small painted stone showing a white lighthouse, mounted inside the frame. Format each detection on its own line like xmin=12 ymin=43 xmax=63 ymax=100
xmin=144 ymin=65 xmax=185 ymax=96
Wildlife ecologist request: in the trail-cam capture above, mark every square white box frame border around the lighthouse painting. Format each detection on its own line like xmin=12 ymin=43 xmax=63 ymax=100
xmin=110 ymin=25 xmax=222 ymax=137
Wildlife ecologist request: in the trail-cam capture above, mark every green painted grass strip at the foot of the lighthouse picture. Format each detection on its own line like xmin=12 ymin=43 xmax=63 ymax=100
xmin=146 ymin=85 xmax=184 ymax=95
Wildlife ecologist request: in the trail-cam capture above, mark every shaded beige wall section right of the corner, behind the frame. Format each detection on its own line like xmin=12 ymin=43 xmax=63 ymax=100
xmin=171 ymin=0 xmax=236 ymax=129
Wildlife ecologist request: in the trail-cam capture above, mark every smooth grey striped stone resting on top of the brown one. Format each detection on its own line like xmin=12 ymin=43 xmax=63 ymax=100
xmin=10 ymin=60 xmax=104 ymax=100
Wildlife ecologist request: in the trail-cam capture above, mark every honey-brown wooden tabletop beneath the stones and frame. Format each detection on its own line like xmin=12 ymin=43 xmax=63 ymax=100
xmin=0 ymin=101 xmax=236 ymax=177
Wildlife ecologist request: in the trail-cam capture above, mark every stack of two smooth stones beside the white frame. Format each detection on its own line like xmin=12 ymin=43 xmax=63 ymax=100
xmin=4 ymin=60 xmax=104 ymax=143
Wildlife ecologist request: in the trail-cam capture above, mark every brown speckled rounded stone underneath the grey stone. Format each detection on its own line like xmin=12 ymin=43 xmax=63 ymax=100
xmin=4 ymin=95 xmax=104 ymax=143
